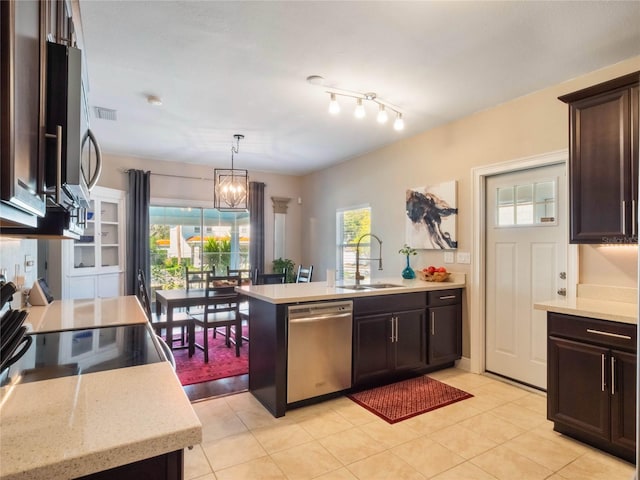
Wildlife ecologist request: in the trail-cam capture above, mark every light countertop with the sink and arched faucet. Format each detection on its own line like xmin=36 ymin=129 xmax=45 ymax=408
xmin=236 ymin=273 xmax=465 ymax=304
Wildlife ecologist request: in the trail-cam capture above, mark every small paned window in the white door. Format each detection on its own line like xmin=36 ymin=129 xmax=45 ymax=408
xmin=496 ymin=180 xmax=557 ymax=227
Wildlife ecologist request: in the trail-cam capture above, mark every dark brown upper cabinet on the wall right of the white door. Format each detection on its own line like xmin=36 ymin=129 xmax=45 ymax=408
xmin=559 ymin=72 xmax=640 ymax=244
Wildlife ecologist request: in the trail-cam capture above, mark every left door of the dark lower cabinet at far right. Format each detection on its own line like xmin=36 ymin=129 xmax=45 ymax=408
xmin=547 ymin=337 xmax=610 ymax=440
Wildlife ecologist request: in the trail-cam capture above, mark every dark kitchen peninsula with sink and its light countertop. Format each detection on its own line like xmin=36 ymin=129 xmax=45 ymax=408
xmin=237 ymin=274 xmax=465 ymax=417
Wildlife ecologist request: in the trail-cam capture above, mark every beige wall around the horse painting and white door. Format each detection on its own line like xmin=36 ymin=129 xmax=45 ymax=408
xmin=302 ymin=57 xmax=640 ymax=356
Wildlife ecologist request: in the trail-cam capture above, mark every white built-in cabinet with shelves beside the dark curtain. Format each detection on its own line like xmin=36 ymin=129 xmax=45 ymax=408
xmin=48 ymin=187 xmax=126 ymax=299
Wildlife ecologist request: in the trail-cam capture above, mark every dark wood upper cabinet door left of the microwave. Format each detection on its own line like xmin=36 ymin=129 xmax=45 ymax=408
xmin=0 ymin=0 xmax=46 ymax=221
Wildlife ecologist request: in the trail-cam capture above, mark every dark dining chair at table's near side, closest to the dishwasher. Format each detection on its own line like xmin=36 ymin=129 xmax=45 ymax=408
xmin=194 ymin=273 xmax=242 ymax=363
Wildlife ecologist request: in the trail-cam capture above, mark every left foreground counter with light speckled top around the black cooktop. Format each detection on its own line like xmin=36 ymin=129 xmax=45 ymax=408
xmin=0 ymin=296 xmax=202 ymax=480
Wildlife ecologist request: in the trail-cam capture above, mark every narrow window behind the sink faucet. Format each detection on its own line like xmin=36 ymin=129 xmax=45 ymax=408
xmin=336 ymin=207 xmax=371 ymax=280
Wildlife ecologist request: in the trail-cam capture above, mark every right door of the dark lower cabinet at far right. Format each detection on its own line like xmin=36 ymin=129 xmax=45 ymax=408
xmin=609 ymin=350 xmax=637 ymax=452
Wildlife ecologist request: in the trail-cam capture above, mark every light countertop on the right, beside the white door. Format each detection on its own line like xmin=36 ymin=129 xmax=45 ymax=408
xmin=533 ymin=297 xmax=638 ymax=325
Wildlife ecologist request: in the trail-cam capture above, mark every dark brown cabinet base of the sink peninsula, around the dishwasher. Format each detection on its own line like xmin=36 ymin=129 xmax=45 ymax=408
xmin=240 ymin=281 xmax=462 ymax=418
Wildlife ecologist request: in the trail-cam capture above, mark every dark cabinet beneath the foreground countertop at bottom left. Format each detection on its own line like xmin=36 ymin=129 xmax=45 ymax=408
xmin=76 ymin=450 xmax=184 ymax=480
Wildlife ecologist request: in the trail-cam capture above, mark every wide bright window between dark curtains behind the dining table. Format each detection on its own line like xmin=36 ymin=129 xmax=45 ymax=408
xmin=149 ymin=206 xmax=250 ymax=290
